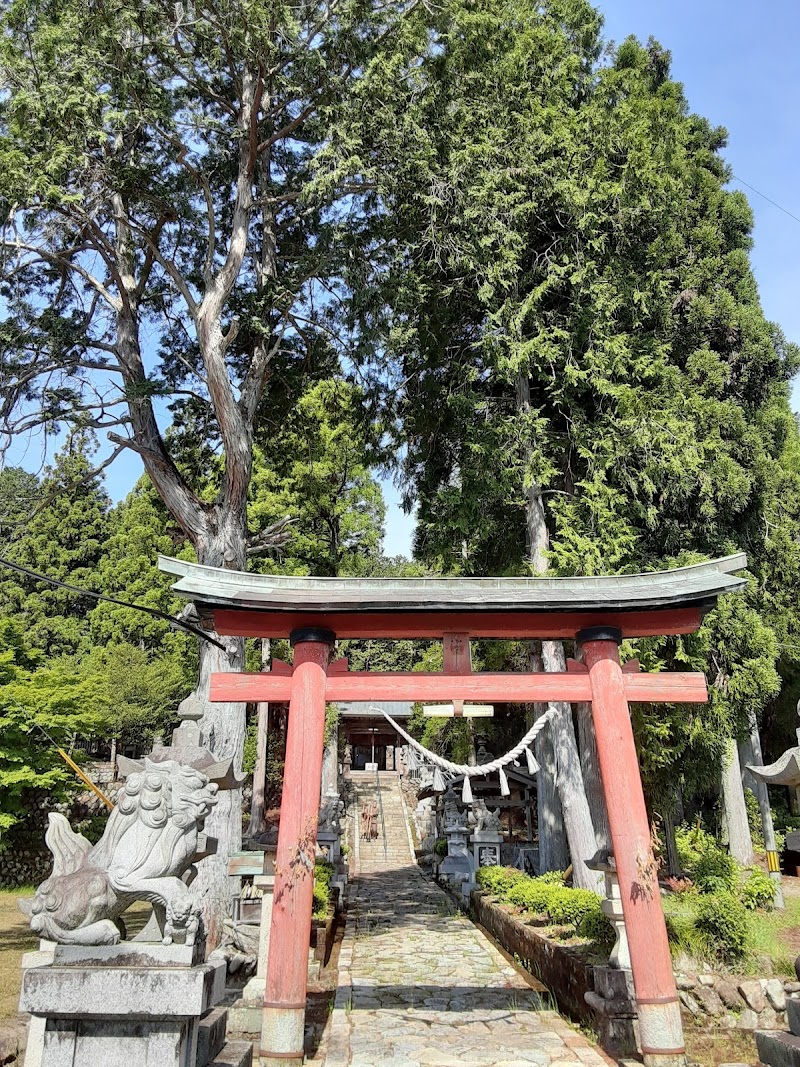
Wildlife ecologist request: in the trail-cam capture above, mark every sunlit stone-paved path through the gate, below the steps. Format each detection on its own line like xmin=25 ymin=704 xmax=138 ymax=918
xmin=324 ymin=862 xmax=612 ymax=1067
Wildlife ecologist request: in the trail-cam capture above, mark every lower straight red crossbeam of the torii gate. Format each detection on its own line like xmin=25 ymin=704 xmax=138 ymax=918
xmin=210 ymin=664 xmax=708 ymax=704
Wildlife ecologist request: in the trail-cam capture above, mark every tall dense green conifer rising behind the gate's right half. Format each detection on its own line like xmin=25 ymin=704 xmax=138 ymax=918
xmin=352 ymin=0 xmax=799 ymax=849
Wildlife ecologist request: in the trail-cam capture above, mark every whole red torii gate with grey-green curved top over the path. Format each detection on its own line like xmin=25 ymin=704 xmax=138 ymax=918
xmin=160 ymin=554 xmax=747 ymax=1067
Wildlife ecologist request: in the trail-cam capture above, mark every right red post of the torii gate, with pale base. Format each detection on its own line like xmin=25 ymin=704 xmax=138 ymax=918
xmin=577 ymin=626 xmax=685 ymax=1067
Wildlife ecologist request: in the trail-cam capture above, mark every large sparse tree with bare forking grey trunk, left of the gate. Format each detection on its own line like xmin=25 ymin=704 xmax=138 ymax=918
xmin=0 ymin=0 xmax=427 ymax=945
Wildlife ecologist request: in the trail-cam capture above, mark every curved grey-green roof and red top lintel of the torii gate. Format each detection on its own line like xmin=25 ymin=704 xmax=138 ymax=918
xmin=159 ymin=553 xmax=747 ymax=638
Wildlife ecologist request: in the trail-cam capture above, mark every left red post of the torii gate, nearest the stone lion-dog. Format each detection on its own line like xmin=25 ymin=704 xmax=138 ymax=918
xmin=259 ymin=627 xmax=335 ymax=1067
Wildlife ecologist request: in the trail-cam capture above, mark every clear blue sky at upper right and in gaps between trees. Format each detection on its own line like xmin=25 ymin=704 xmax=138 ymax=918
xmin=7 ymin=0 xmax=800 ymax=555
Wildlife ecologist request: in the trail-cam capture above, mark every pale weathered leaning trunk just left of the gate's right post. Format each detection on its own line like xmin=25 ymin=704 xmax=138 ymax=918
xmin=516 ymin=373 xmax=603 ymax=895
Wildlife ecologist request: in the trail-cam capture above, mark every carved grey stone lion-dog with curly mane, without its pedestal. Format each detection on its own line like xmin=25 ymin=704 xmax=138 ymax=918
xmin=30 ymin=759 xmax=218 ymax=944
